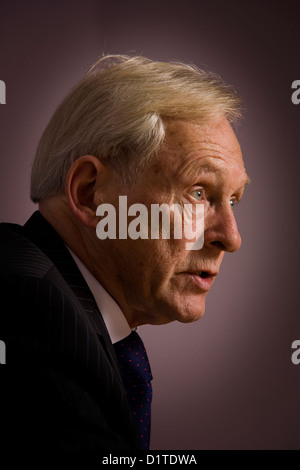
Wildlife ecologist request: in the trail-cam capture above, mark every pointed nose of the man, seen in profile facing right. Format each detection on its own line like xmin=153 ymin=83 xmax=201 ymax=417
xmin=204 ymin=204 xmax=242 ymax=253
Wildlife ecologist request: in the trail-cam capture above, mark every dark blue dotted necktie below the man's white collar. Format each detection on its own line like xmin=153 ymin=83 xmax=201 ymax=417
xmin=114 ymin=331 xmax=152 ymax=450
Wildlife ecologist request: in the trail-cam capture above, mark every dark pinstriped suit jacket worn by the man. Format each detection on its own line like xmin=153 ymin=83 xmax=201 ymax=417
xmin=0 ymin=212 xmax=138 ymax=451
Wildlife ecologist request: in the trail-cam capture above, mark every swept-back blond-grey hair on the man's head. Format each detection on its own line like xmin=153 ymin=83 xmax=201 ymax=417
xmin=31 ymin=55 xmax=241 ymax=202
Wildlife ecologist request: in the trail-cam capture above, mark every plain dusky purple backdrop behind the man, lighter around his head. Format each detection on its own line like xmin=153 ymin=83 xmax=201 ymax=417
xmin=0 ymin=0 xmax=300 ymax=449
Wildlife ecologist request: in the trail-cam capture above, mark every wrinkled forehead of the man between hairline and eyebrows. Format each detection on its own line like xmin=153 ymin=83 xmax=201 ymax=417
xmin=163 ymin=118 xmax=247 ymax=183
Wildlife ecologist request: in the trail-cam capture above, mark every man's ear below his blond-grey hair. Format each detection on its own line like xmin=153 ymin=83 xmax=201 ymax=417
xmin=66 ymin=155 xmax=107 ymax=228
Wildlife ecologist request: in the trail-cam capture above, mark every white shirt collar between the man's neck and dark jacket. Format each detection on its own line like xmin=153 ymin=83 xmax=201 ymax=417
xmin=67 ymin=246 xmax=131 ymax=343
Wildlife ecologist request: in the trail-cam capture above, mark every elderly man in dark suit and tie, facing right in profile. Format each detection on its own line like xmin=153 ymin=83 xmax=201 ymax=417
xmin=0 ymin=56 xmax=248 ymax=450
